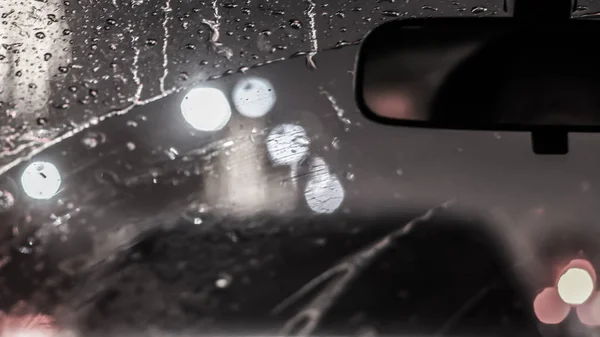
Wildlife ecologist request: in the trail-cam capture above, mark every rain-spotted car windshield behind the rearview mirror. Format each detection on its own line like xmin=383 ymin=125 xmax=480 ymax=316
xmin=0 ymin=0 xmax=600 ymax=337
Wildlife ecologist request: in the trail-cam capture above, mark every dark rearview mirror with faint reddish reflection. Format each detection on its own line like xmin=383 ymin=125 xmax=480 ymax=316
xmin=355 ymin=18 xmax=600 ymax=153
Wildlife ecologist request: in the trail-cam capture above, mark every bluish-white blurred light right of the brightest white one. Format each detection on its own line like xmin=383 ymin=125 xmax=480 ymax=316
xmin=232 ymin=77 xmax=277 ymax=118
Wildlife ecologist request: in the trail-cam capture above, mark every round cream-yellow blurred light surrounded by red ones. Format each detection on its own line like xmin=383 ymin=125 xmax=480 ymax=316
xmin=557 ymin=268 xmax=594 ymax=305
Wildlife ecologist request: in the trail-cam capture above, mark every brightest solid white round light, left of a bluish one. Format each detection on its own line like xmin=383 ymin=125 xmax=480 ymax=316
xmin=181 ymin=88 xmax=231 ymax=131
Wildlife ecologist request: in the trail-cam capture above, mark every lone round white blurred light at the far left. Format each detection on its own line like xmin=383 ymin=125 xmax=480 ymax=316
xmin=21 ymin=161 xmax=62 ymax=200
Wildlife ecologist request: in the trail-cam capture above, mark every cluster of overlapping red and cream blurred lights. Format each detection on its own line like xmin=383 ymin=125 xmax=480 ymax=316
xmin=533 ymin=259 xmax=600 ymax=326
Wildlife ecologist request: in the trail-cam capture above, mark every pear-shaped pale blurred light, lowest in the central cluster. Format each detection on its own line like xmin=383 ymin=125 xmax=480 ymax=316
xmin=304 ymin=158 xmax=344 ymax=214
